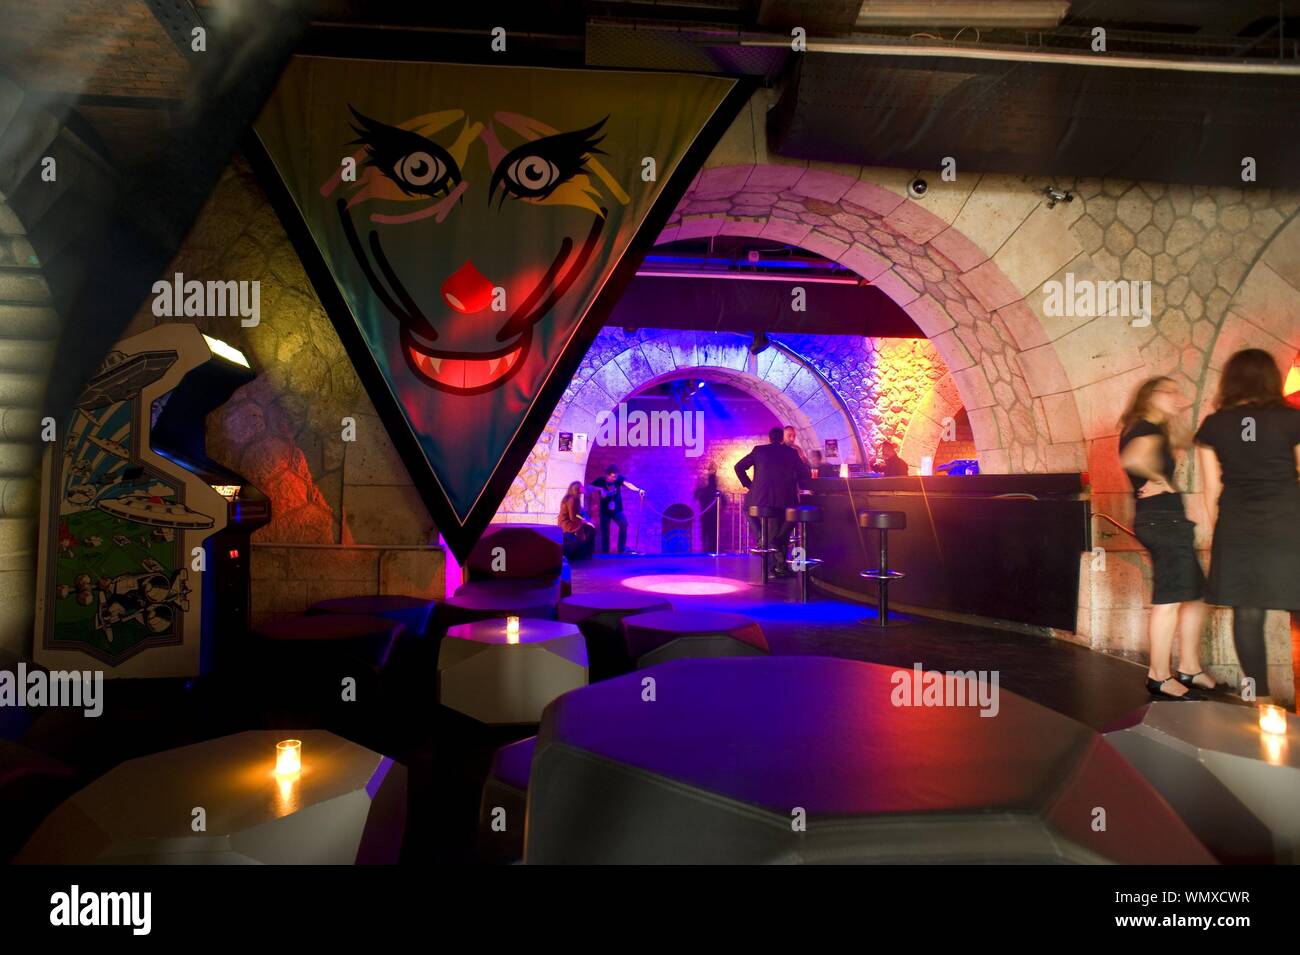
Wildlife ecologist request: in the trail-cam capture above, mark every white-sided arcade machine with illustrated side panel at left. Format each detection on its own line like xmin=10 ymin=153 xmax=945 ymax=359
xmin=34 ymin=324 xmax=270 ymax=677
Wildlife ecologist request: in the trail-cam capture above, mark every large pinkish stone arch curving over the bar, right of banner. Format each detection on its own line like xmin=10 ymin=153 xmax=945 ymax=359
xmin=659 ymin=162 xmax=1086 ymax=473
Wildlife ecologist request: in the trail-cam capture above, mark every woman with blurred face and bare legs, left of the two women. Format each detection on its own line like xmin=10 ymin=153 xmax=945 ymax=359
xmin=1119 ymin=378 xmax=1216 ymax=700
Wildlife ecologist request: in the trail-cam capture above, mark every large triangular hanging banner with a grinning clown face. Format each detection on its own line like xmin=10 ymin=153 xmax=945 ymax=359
xmin=256 ymin=57 xmax=746 ymax=559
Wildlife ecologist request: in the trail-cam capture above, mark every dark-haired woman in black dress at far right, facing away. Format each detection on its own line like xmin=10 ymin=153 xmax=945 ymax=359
xmin=1196 ymin=348 xmax=1300 ymax=702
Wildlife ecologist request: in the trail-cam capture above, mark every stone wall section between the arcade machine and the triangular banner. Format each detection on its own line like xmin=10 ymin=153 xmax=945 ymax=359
xmin=124 ymin=160 xmax=442 ymax=613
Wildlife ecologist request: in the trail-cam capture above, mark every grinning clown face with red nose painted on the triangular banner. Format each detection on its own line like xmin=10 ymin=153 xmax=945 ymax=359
xmin=330 ymin=109 xmax=628 ymax=395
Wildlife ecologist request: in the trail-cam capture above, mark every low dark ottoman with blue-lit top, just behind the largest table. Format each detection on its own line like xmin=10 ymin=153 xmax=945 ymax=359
xmin=623 ymin=611 xmax=768 ymax=668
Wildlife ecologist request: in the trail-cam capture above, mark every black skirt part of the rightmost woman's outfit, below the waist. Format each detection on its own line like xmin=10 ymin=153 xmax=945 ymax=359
xmin=1206 ymin=485 xmax=1300 ymax=611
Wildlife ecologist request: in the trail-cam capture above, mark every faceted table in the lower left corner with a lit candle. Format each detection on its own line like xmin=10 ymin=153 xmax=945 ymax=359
xmin=16 ymin=730 xmax=407 ymax=865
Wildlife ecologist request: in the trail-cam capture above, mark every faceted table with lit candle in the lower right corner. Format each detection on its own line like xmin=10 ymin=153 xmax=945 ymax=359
xmin=1105 ymin=700 xmax=1300 ymax=864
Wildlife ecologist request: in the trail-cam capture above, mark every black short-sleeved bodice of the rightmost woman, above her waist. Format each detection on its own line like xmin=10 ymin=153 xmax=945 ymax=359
xmin=1196 ymin=404 xmax=1300 ymax=494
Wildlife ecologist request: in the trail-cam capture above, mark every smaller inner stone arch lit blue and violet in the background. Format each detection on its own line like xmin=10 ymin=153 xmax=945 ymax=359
xmin=517 ymin=330 xmax=863 ymax=522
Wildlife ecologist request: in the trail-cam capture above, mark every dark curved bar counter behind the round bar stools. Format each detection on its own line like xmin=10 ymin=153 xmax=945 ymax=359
xmin=803 ymin=473 xmax=1092 ymax=630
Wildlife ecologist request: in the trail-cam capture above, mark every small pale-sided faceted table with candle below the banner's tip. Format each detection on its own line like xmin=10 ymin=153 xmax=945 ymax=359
xmin=438 ymin=617 xmax=588 ymax=724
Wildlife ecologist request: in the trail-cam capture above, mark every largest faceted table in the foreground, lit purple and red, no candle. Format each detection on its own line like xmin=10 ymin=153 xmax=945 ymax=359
xmin=524 ymin=657 xmax=1213 ymax=864
